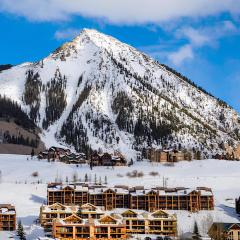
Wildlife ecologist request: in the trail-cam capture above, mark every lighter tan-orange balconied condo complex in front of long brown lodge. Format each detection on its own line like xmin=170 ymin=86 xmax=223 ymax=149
xmin=40 ymin=203 xmax=177 ymax=239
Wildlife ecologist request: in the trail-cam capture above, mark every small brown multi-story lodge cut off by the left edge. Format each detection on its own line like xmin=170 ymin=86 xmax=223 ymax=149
xmin=0 ymin=204 xmax=16 ymax=231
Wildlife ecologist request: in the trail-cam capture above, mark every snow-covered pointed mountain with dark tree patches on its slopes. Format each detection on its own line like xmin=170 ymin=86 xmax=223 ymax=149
xmin=0 ymin=29 xmax=240 ymax=157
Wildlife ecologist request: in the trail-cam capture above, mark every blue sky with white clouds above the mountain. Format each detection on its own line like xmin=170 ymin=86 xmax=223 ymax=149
xmin=0 ymin=0 xmax=240 ymax=112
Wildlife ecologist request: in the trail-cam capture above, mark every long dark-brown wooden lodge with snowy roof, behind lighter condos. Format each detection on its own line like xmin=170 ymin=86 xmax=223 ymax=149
xmin=47 ymin=184 xmax=214 ymax=212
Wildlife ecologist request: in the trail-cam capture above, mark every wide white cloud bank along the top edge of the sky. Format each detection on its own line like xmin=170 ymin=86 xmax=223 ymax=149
xmin=0 ymin=0 xmax=240 ymax=24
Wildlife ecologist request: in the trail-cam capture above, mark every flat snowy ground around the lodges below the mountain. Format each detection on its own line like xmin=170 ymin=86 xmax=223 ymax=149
xmin=0 ymin=155 xmax=240 ymax=240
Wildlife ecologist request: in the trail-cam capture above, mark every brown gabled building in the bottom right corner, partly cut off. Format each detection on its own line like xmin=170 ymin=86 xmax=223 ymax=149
xmin=208 ymin=222 xmax=240 ymax=240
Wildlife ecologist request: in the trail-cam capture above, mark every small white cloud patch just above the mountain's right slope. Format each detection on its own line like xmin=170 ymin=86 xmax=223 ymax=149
xmin=168 ymin=44 xmax=194 ymax=66
